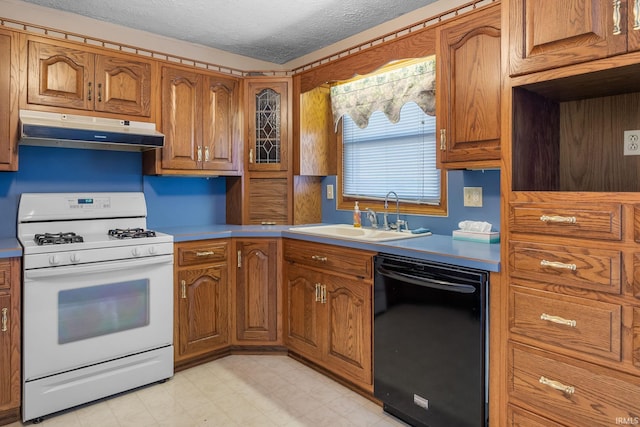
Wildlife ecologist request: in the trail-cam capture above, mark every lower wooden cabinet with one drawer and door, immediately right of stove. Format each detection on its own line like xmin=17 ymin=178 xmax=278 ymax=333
xmin=174 ymin=240 xmax=230 ymax=365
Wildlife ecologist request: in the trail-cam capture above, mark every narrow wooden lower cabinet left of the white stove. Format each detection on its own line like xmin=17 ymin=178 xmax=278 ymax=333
xmin=0 ymin=258 xmax=21 ymax=425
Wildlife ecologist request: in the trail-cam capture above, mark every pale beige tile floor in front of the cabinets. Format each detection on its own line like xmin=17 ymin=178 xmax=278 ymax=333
xmin=9 ymin=355 xmax=406 ymax=427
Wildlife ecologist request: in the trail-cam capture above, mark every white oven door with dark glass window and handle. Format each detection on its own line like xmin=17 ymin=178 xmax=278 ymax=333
xmin=23 ymin=255 xmax=173 ymax=381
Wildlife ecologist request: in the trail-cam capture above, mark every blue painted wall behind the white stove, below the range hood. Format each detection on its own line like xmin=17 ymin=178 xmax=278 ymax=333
xmin=0 ymin=146 xmax=226 ymax=237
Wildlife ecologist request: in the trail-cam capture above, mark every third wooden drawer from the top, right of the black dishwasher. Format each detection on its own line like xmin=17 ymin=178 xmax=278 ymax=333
xmin=509 ymin=285 xmax=622 ymax=360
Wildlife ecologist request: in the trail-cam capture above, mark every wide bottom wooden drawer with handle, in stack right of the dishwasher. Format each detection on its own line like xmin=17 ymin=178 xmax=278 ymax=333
xmin=508 ymin=344 xmax=640 ymax=427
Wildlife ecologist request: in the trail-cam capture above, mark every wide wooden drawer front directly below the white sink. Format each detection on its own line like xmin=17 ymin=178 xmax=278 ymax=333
xmin=284 ymin=239 xmax=373 ymax=279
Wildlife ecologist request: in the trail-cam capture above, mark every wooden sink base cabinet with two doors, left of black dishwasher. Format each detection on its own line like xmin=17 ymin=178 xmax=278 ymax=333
xmin=284 ymin=240 xmax=373 ymax=391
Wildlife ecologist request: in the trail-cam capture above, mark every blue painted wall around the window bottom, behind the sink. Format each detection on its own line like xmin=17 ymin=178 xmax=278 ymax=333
xmin=322 ymin=170 xmax=500 ymax=235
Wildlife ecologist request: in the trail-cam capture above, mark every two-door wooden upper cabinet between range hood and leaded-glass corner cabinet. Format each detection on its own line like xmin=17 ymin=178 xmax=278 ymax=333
xmin=150 ymin=67 xmax=240 ymax=175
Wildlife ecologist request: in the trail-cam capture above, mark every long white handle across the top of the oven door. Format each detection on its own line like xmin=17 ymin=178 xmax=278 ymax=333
xmin=24 ymin=255 xmax=173 ymax=280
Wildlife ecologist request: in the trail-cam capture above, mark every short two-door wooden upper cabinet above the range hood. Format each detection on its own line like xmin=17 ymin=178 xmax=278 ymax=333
xmin=27 ymin=40 xmax=151 ymax=117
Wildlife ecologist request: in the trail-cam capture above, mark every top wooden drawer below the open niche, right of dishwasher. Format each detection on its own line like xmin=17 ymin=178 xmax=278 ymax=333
xmin=509 ymin=203 xmax=622 ymax=240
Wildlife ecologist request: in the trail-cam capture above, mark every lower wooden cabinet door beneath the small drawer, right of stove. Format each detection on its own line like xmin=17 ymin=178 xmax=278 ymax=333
xmin=175 ymin=264 xmax=229 ymax=360
